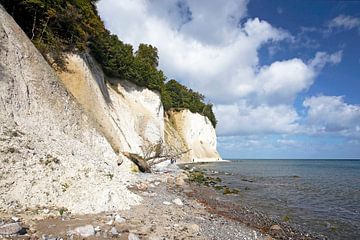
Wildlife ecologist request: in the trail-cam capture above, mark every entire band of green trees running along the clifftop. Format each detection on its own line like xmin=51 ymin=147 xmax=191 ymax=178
xmin=0 ymin=0 xmax=216 ymax=127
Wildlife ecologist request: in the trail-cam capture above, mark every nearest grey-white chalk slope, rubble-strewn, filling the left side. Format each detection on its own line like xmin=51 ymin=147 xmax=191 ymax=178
xmin=0 ymin=6 xmax=140 ymax=213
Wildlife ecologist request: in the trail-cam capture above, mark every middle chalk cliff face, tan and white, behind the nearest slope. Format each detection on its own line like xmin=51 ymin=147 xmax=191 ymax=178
xmin=58 ymin=54 xmax=164 ymax=155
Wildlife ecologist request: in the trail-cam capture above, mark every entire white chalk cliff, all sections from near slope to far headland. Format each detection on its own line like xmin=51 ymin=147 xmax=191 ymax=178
xmin=0 ymin=6 xmax=220 ymax=213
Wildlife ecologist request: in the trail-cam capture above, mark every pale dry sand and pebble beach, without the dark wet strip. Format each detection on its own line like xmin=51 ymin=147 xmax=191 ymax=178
xmin=0 ymin=169 xmax=271 ymax=240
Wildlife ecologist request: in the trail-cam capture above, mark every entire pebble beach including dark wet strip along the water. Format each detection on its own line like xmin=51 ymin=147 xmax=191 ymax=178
xmin=0 ymin=166 xmax=326 ymax=240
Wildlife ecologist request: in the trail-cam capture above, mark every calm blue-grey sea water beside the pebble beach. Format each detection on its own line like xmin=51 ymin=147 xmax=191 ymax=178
xmin=195 ymin=160 xmax=360 ymax=239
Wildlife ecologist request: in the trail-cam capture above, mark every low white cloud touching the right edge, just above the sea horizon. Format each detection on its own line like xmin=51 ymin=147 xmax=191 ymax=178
xmin=303 ymin=96 xmax=360 ymax=136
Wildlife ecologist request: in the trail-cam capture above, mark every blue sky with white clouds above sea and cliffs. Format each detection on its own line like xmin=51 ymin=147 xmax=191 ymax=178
xmin=98 ymin=0 xmax=360 ymax=159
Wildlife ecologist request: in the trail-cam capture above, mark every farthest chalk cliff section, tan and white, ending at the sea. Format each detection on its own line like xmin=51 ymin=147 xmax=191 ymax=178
xmin=165 ymin=109 xmax=221 ymax=162
